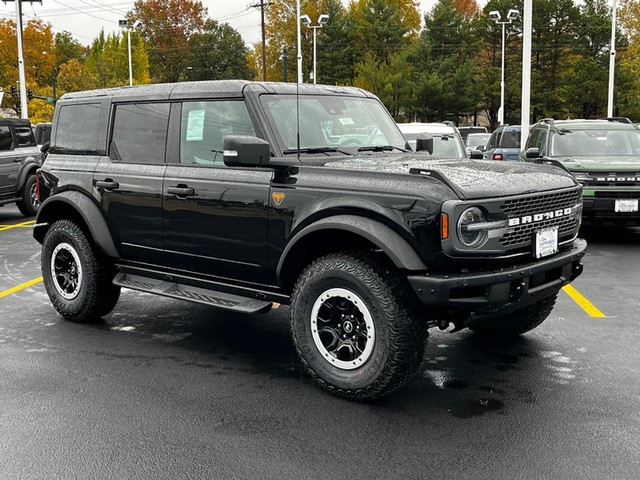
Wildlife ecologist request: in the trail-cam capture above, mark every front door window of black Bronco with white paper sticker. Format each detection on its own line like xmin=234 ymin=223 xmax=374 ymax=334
xmin=180 ymin=100 xmax=255 ymax=165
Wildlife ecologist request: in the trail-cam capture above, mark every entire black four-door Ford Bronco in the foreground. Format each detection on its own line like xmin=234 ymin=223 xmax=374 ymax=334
xmin=34 ymin=81 xmax=586 ymax=400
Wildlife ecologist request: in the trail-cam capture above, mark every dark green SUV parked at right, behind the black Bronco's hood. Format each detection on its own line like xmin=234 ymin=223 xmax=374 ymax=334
xmin=523 ymin=118 xmax=640 ymax=226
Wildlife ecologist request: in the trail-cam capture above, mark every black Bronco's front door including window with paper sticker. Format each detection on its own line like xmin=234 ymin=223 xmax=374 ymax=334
xmin=162 ymin=98 xmax=273 ymax=282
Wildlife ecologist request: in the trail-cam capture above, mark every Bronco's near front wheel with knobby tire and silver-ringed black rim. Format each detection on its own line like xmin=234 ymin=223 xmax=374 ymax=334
xmin=291 ymin=252 xmax=427 ymax=400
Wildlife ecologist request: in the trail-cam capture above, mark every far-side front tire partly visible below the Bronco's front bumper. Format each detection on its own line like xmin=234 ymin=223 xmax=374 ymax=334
xmin=470 ymin=293 xmax=558 ymax=338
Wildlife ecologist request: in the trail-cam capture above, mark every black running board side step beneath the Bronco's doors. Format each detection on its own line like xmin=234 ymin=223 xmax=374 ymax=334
xmin=113 ymin=272 xmax=273 ymax=313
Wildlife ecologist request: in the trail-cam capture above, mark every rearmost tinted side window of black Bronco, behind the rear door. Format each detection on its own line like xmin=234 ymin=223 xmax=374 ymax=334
xmin=54 ymin=103 xmax=102 ymax=154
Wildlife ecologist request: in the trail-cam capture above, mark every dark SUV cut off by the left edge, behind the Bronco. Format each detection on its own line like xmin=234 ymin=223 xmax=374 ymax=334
xmin=0 ymin=118 xmax=42 ymax=216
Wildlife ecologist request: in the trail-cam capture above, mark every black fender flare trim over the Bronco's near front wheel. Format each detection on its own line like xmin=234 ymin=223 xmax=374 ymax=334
xmin=276 ymin=215 xmax=427 ymax=284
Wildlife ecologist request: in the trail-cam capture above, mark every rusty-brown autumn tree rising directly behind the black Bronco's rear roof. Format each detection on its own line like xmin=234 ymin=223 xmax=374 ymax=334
xmin=127 ymin=0 xmax=207 ymax=82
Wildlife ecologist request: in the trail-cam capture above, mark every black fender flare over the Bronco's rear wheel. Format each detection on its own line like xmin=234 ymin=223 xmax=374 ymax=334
xmin=33 ymin=190 xmax=120 ymax=258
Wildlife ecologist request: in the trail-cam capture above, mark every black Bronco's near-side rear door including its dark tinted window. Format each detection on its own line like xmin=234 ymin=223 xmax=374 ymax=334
xmin=93 ymin=102 xmax=170 ymax=263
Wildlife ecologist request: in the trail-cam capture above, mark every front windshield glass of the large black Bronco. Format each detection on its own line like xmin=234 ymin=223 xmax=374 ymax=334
xmin=260 ymin=95 xmax=406 ymax=152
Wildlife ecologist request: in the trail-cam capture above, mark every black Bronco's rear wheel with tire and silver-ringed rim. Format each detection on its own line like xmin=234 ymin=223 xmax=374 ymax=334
xmin=41 ymin=220 xmax=120 ymax=323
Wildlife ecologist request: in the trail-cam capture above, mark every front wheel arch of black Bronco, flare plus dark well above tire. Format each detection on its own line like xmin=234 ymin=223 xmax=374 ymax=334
xmin=276 ymin=215 xmax=427 ymax=290
